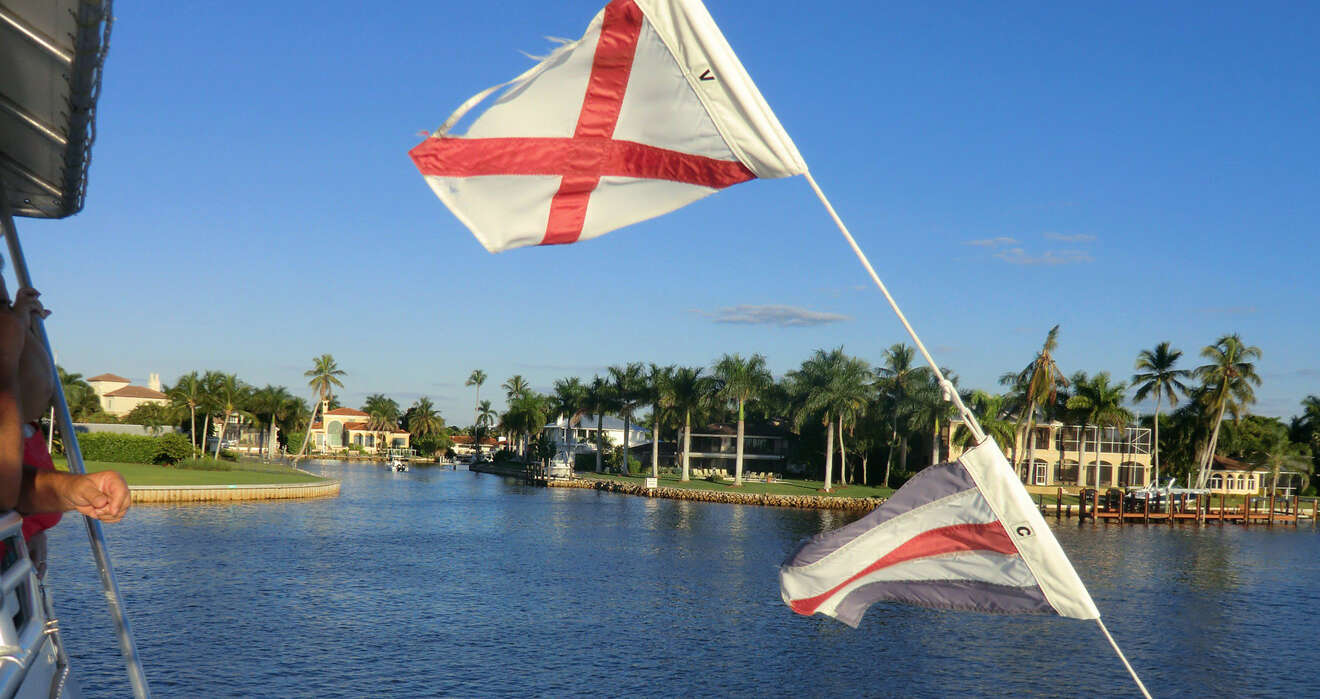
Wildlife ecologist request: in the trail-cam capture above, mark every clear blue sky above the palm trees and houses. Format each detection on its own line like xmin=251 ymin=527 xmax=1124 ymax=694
xmin=18 ymin=0 xmax=1320 ymax=425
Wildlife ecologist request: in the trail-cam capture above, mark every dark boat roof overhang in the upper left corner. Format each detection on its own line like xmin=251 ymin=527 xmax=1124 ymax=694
xmin=0 ymin=0 xmax=112 ymax=219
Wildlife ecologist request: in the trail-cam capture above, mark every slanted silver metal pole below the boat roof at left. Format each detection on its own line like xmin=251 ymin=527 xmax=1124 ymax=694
xmin=0 ymin=182 xmax=150 ymax=699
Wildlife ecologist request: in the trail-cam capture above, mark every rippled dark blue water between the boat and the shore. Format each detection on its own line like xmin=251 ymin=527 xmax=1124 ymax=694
xmin=50 ymin=462 xmax=1320 ymax=698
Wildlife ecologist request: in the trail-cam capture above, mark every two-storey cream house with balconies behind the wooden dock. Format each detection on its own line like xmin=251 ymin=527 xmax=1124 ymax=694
xmin=946 ymin=421 xmax=1152 ymax=488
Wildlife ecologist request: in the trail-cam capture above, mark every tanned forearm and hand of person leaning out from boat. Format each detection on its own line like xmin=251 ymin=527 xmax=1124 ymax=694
xmin=16 ymin=466 xmax=131 ymax=522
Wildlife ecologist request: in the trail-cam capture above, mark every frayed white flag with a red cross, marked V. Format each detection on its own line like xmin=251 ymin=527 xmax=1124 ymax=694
xmin=411 ymin=0 xmax=807 ymax=252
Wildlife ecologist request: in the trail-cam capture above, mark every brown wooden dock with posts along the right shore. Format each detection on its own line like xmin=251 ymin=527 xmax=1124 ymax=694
xmin=1036 ymin=488 xmax=1320 ymax=526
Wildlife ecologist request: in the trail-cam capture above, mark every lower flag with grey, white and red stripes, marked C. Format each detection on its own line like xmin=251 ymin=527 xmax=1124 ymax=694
xmin=779 ymin=438 xmax=1100 ymax=626
